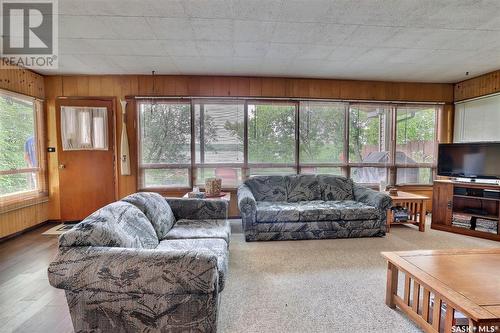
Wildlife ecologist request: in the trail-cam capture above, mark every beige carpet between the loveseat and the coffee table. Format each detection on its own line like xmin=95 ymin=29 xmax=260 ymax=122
xmin=219 ymin=218 xmax=500 ymax=333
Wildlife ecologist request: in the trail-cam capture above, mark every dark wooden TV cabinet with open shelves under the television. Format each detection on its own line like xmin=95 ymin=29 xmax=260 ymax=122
xmin=431 ymin=180 xmax=500 ymax=241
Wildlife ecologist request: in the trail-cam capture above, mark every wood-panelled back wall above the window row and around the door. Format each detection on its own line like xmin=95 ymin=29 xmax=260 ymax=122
xmin=45 ymin=75 xmax=453 ymax=219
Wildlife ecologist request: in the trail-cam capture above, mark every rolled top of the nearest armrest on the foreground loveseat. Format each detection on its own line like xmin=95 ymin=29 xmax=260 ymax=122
xmin=48 ymin=247 xmax=219 ymax=295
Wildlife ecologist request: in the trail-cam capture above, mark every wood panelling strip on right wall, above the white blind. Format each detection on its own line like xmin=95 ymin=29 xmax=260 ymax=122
xmin=454 ymin=70 xmax=500 ymax=102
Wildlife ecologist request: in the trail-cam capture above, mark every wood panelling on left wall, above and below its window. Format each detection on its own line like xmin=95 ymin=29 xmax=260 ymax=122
xmin=0 ymin=64 xmax=49 ymax=239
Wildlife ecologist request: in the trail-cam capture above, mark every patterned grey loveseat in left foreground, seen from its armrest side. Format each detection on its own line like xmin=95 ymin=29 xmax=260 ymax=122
xmin=48 ymin=193 xmax=230 ymax=332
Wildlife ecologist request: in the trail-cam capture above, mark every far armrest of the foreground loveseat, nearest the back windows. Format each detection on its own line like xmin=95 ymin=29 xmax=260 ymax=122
xmin=165 ymin=198 xmax=228 ymax=220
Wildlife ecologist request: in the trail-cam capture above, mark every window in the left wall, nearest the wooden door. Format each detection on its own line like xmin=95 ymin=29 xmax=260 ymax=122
xmin=0 ymin=91 xmax=46 ymax=202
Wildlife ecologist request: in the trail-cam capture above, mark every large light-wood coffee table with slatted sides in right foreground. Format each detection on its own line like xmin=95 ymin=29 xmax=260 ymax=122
xmin=382 ymin=248 xmax=500 ymax=333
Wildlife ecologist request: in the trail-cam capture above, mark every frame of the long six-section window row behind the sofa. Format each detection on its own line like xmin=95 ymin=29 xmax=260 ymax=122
xmin=136 ymin=97 xmax=444 ymax=191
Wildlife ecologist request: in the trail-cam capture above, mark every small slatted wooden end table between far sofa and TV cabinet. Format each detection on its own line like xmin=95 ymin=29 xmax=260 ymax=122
xmin=386 ymin=191 xmax=429 ymax=232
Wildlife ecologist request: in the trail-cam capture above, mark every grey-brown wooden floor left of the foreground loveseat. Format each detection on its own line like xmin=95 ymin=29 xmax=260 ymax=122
xmin=0 ymin=224 xmax=73 ymax=333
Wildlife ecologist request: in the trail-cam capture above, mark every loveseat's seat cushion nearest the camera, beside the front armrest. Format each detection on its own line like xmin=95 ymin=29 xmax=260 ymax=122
xmin=157 ymin=238 xmax=229 ymax=292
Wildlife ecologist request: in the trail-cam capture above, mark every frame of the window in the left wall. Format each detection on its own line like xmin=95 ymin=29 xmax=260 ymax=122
xmin=0 ymin=89 xmax=48 ymax=209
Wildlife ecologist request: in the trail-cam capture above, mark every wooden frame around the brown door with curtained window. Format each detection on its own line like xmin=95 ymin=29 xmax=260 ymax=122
xmin=56 ymin=96 xmax=119 ymax=201
